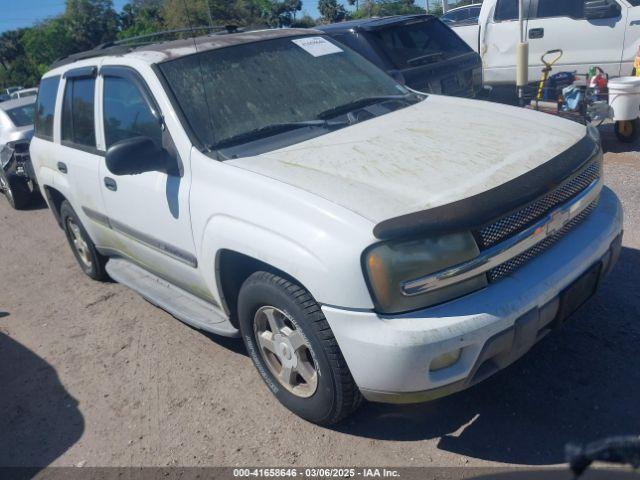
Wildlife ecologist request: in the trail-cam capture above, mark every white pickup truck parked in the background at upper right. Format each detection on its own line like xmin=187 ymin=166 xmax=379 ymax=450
xmin=452 ymin=0 xmax=640 ymax=85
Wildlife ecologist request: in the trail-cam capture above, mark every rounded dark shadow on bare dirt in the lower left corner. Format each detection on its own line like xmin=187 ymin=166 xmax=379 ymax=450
xmin=0 ymin=320 xmax=84 ymax=467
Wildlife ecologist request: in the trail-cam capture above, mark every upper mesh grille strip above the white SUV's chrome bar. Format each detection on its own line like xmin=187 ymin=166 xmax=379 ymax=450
xmin=476 ymin=157 xmax=602 ymax=250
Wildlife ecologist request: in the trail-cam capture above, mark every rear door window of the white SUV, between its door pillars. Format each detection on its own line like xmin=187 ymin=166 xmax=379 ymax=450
xmin=62 ymin=77 xmax=96 ymax=147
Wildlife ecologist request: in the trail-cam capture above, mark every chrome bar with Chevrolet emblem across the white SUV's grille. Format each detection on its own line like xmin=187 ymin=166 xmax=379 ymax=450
xmin=400 ymin=178 xmax=602 ymax=297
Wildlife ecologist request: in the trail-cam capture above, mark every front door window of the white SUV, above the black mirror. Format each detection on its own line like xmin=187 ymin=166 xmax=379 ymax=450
xmin=103 ymin=77 xmax=162 ymax=148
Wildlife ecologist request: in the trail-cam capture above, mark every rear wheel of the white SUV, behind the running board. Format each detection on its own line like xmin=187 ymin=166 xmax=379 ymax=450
xmin=60 ymin=200 xmax=108 ymax=280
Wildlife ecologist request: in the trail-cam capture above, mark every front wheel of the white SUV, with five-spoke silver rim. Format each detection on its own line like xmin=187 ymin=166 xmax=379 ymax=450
xmin=238 ymin=272 xmax=362 ymax=425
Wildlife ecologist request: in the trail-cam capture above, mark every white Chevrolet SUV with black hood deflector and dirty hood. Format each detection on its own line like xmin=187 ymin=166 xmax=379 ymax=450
xmin=31 ymin=29 xmax=622 ymax=424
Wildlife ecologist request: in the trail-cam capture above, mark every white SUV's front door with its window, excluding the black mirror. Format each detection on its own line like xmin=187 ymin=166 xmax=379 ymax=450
xmin=100 ymin=67 xmax=199 ymax=290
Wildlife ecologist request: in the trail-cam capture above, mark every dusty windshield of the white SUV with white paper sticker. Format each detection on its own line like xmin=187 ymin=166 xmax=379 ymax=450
xmin=160 ymin=36 xmax=416 ymax=156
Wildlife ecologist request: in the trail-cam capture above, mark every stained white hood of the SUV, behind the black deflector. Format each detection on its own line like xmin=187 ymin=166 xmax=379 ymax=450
xmin=227 ymin=95 xmax=585 ymax=228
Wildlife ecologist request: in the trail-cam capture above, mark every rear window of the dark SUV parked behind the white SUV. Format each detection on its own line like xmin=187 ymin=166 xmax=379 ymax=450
xmin=370 ymin=18 xmax=471 ymax=70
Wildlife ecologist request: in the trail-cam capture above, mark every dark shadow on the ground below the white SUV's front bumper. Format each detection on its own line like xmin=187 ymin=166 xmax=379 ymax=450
xmin=337 ymin=248 xmax=640 ymax=465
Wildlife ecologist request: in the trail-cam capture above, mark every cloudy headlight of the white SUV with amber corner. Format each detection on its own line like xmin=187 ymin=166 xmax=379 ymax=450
xmin=363 ymin=232 xmax=487 ymax=313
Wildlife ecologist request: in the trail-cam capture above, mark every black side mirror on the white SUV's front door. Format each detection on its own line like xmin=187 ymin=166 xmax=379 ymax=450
xmin=105 ymin=137 xmax=169 ymax=175
